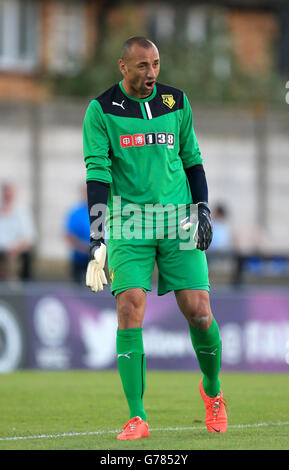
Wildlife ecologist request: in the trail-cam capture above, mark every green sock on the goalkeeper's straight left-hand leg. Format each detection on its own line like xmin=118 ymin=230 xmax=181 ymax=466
xmin=116 ymin=328 xmax=147 ymax=421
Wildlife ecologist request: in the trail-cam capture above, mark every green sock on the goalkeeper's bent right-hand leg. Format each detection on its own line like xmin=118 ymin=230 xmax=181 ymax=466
xmin=190 ymin=318 xmax=222 ymax=397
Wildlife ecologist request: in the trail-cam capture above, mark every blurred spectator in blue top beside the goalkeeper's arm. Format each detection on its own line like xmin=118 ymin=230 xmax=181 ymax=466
xmin=65 ymin=188 xmax=90 ymax=284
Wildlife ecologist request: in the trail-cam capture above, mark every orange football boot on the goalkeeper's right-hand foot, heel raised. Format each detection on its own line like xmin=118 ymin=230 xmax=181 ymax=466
xmin=200 ymin=380 xmax=228 ymax=433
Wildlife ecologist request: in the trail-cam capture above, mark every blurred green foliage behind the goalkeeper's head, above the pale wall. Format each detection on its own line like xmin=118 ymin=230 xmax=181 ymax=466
xmin=50 ymin=39 xmax=285 ymax=106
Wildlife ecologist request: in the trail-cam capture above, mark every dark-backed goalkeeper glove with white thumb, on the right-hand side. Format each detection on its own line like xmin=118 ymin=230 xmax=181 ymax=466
xmin=181 ymin=202 xmax=213 ymax=251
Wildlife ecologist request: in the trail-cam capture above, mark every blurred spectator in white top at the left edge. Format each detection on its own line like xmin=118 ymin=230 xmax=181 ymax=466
xmin=0 ymin=183 xmax=36 ymax=281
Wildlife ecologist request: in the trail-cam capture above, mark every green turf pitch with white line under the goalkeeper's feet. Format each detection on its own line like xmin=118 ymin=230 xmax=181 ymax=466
xmin=0 ymin=371 xmax=289 ymax=450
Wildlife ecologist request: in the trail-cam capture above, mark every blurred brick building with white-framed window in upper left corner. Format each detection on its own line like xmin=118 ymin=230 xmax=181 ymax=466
xmin=0 ymin=0 xmax=99 ymax=101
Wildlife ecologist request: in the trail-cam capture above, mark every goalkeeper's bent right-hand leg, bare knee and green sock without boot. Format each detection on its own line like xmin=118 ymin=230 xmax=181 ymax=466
xmin=175 ymin=289 xmax=221 ymax=397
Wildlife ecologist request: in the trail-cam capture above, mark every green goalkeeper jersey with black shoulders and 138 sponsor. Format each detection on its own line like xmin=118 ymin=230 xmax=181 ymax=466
xmin=83 ymin=82 xmax=203 ymax=234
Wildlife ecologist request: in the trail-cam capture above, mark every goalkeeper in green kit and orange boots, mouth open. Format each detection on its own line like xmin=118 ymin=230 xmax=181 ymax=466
xmin=83 ymin=37 xmax=227 ymax=440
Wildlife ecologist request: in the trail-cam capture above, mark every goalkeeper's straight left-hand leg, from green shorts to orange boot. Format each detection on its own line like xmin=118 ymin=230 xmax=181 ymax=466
xmin=107 ymin=239 xmax=156 ymax=439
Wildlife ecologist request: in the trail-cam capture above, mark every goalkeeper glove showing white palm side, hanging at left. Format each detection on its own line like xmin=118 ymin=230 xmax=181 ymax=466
xmin=86 ymin=238 xmax=107 ymax=292
